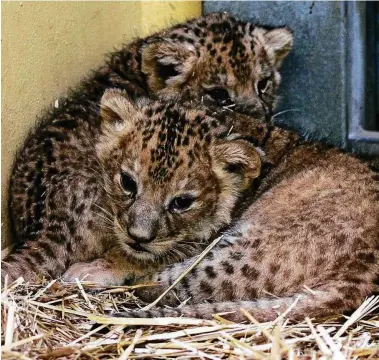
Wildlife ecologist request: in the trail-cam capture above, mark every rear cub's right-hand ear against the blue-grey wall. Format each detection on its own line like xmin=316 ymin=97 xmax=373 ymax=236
xmin=263 ymin=28 xmax=293 ymax=67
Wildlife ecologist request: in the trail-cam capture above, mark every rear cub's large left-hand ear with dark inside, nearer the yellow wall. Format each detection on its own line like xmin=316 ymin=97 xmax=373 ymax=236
xmin=142 ymin=39 xmax=197 ymax=92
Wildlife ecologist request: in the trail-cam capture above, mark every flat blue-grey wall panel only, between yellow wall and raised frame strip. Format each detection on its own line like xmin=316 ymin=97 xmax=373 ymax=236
xmin=204 ymin=1 xmax=346 ymax=147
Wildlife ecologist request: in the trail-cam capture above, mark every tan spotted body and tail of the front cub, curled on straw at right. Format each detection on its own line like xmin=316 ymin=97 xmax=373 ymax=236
xmin=118 ymin=116 xmax=379 ymax=321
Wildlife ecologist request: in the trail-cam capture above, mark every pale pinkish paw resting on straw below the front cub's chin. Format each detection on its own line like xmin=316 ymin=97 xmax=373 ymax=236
xmin=62 ymin=260 xmax=126 ymax=285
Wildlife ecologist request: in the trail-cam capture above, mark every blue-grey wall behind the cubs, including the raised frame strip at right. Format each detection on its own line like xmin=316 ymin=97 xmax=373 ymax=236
xmin=203 ymin=1 xmax=379 ymax=154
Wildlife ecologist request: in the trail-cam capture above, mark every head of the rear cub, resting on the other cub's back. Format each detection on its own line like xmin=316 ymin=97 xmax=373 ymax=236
xmin=142 ymin=13 xmax=293 ymax=118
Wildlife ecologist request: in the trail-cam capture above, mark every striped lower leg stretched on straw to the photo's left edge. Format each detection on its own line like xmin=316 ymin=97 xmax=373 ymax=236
xmin=1 ymin=196 xmax=108 ymax=282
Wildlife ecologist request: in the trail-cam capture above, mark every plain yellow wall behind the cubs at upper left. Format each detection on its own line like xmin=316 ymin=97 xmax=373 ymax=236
xmin=1 ymin=1 xmax=201 ymax=243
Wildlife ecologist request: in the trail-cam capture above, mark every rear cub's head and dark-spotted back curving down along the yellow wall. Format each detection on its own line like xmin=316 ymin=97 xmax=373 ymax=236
xmin=7 ymin=14 xmax=292 ymax=282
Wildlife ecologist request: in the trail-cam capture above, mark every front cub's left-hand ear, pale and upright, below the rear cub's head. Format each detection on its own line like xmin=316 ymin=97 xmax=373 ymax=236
xmin=100 ymin=89 xmax=140 ymax=131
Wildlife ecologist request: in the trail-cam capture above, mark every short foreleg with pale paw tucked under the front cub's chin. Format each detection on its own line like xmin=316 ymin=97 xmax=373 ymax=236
xmin=63 ymin=246 xmax=157 ymax=285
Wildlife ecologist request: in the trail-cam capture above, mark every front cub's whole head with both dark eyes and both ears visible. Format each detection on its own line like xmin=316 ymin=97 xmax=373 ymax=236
xmin=97 ymin=90 xmax=261 ymax=260
